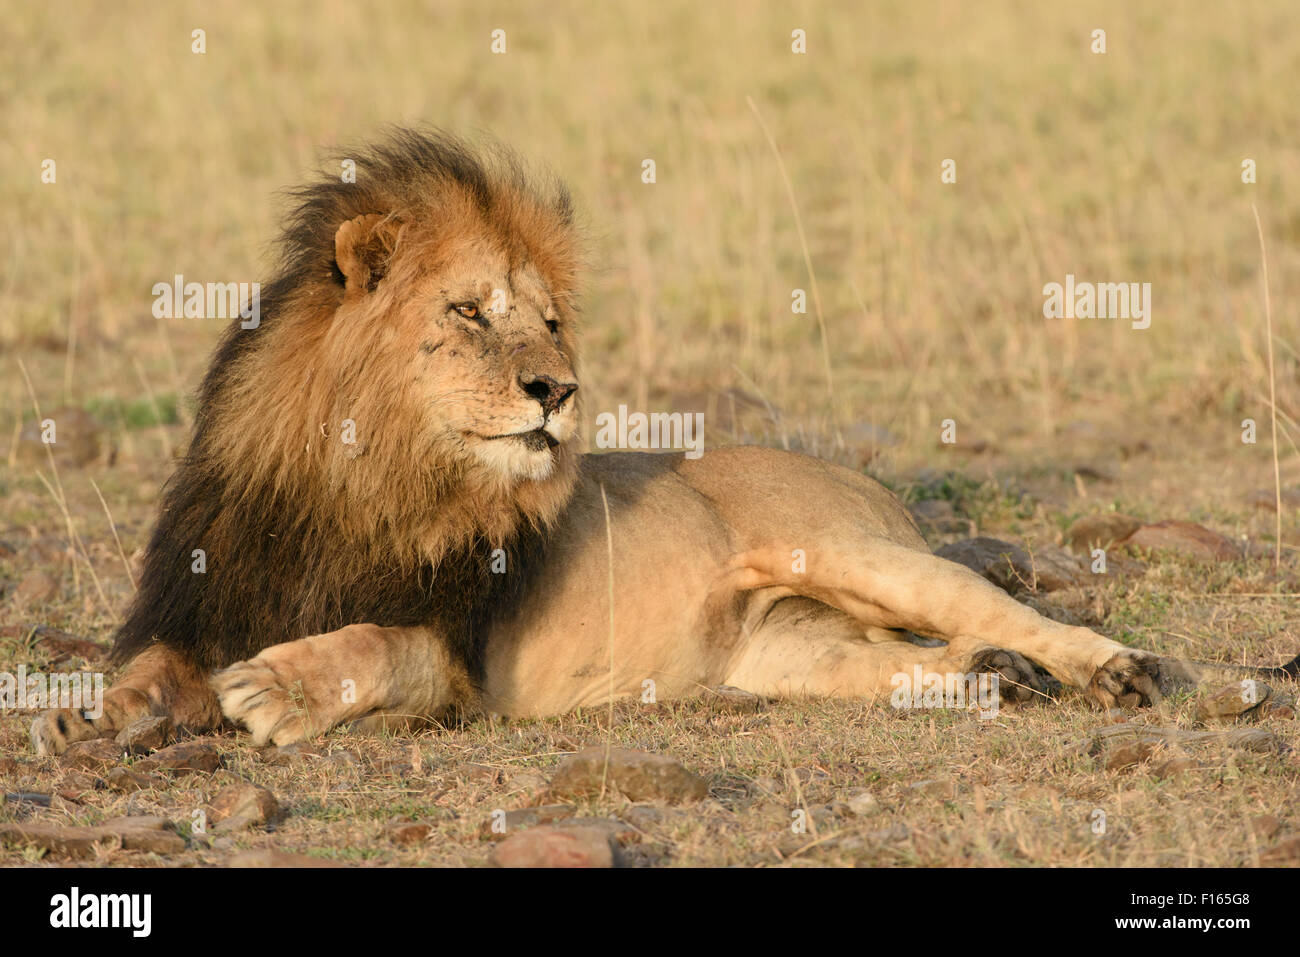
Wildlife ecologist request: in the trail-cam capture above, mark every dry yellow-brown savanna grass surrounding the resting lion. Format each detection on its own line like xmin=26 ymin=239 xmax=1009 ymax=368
xmin=0 ymin=0 xmax=1300 ymax=866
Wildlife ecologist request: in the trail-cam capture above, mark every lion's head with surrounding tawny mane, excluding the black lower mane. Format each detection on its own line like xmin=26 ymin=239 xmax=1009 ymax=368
xmin=212 ymin=131 xmax=579 ymax=546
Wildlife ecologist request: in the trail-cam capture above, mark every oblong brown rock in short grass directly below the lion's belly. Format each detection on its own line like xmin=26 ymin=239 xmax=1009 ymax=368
xmin=551 ymin=745 xmax=709 ymax=804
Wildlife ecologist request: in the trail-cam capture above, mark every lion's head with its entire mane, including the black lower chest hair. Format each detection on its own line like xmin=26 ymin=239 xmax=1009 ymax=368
xmin=117 ymin=131 xmax=590 ymax=664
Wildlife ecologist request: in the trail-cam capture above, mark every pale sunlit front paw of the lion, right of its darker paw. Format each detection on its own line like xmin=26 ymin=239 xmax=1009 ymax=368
xmin=212 ymin=653 xmax=318 ymax=748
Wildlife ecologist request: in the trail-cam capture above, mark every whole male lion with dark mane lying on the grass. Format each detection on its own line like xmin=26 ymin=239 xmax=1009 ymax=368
xmin=31 ymin=131 xmax=1294 ymax=753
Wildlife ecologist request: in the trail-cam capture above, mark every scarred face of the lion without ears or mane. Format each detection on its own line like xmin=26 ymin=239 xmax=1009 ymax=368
xmin=402 ymin=244 xmax=579 ymax=481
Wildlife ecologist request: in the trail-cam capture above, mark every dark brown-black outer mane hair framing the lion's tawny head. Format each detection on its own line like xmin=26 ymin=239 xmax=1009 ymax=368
xmin=113 ymin=130 xmax=572 ymax=683
